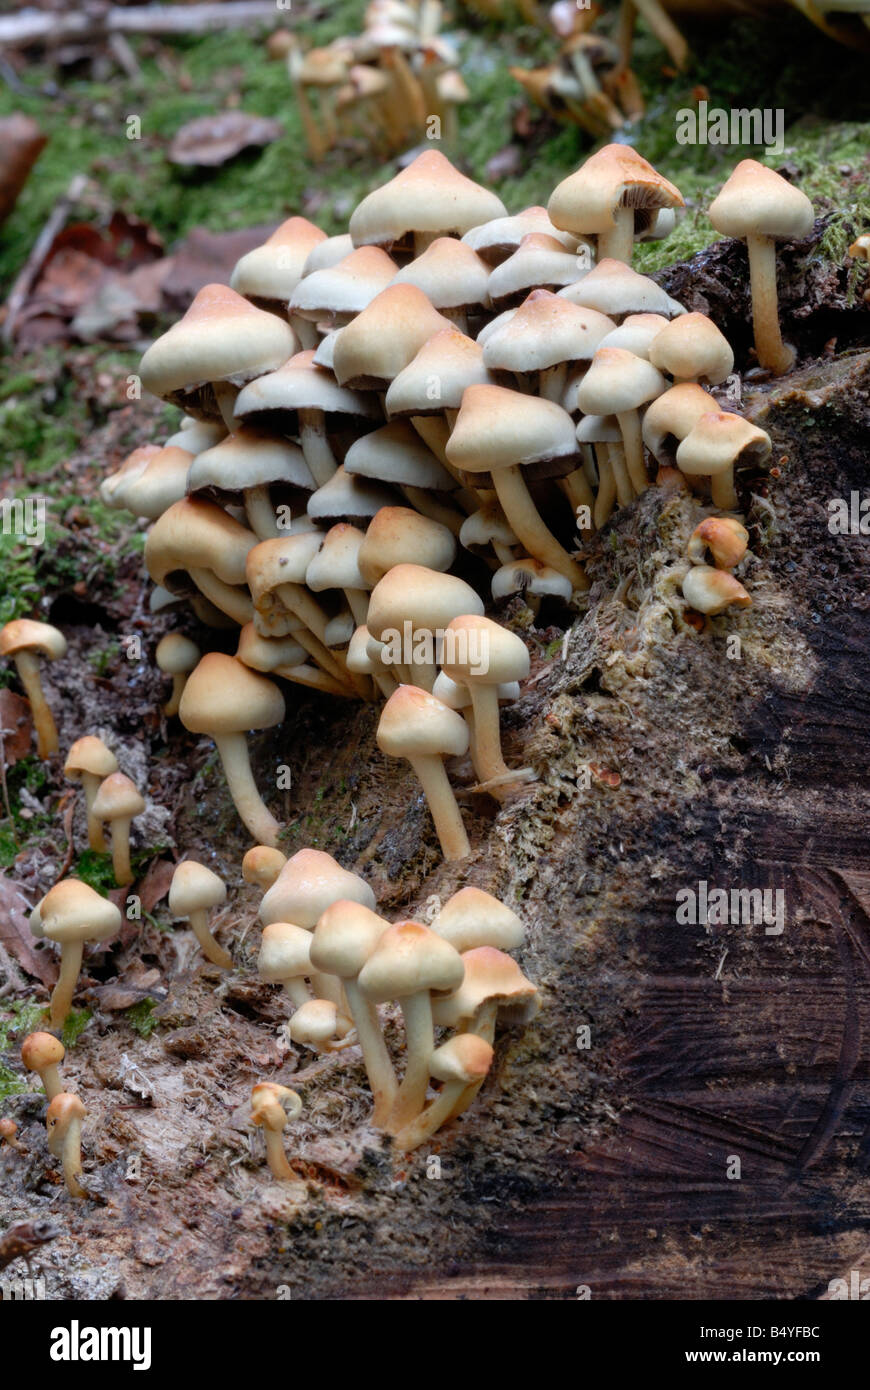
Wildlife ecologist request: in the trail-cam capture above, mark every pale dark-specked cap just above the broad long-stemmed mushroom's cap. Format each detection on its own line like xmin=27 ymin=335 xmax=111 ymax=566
xmin=484 ymin=289 xmax=616 ymax=373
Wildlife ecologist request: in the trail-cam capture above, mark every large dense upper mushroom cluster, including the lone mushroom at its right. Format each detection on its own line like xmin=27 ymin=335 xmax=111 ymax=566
xmin=94 ymin=145 xmax=794 ymax=858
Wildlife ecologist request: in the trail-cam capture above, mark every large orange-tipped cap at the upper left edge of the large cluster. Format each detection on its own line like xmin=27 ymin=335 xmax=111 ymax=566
xmin=139 ymin=285 xmax=296 ymax=399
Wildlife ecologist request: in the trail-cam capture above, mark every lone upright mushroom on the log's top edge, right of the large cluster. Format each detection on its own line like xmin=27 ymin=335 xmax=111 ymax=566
xmin=707 ymin=160 xmax=813 ymax=377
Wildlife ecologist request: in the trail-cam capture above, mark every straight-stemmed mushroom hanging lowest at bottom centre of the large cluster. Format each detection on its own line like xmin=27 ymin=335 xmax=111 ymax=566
xmin=377 ymin=685 xmax=471 ymax=859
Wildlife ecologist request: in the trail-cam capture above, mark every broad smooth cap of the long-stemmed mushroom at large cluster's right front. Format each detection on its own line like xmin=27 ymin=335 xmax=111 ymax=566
xmin=448 ymin=386 xmax=577 ymax=473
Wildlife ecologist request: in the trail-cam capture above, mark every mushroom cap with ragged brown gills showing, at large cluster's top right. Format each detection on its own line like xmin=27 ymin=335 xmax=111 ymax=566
xmin=546 ymin=145 xmax=685 ymax=236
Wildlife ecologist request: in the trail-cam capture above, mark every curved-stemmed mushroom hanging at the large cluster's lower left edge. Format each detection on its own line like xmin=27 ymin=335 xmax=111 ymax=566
xmin=178 ymin=653 xmax=286 ymax=848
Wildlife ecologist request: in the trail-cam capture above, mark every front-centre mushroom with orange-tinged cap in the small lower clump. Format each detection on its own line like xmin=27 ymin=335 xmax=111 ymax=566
xmin=359 ymin=922 xmax=464 ymax=1134
